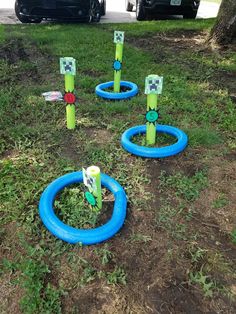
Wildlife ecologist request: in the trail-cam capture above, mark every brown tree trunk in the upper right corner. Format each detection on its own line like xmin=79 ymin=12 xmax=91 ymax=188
xmin=210 ymin=0 xmax=236 ymax=45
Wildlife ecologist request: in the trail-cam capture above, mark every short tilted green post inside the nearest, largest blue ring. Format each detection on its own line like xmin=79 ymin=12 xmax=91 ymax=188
xmin=83 ymin=166 xmax=102 ymax=210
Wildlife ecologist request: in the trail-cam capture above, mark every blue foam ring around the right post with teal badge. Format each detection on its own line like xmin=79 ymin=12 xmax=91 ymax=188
xmin=121 ymin=124 xmax=188 ymax=158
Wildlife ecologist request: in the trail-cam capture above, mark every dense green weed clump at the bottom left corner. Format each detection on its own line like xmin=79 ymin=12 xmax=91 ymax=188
xmin=2 ymin=243 xmax=63 ymax=314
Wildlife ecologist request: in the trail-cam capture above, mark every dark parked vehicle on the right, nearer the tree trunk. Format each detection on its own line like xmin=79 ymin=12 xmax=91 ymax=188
xmin=125 ymin=0 xmax=200 ymax=21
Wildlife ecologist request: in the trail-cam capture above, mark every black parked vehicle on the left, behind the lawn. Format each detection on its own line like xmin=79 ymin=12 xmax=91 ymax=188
xmin=15 ymin=0 xmax=106 ymax=23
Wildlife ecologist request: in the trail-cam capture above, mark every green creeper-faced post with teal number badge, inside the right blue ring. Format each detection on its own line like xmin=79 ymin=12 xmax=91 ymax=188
xmin=145 ymin=74 xmax=163 ymax=145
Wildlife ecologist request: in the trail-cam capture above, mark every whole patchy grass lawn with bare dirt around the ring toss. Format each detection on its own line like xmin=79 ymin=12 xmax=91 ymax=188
xmin=0 ymin=20 xmax=236 ymax=314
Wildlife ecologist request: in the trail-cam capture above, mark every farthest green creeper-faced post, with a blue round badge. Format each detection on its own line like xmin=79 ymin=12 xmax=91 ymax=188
xmin=113 ymin=31 xmax=124 ymax=93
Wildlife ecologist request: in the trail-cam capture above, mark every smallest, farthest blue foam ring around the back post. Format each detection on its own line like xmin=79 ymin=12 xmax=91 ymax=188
xmin=95 ymin=81 xmax=138 ymax=100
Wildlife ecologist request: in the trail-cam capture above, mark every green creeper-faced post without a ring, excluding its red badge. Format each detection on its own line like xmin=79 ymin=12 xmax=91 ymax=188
xmin=60 ymin=57 xmax=76 ymax=130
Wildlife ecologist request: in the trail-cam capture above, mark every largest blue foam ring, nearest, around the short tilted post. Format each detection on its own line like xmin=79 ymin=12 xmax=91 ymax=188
xmin=39 ymin=171 xmax=127 ymax=245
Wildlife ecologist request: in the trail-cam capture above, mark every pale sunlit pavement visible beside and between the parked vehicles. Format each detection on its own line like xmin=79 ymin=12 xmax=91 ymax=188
xmin=0 ymin=0 xmax=219 ymax=24
